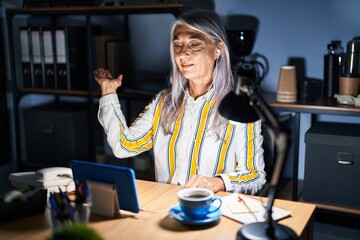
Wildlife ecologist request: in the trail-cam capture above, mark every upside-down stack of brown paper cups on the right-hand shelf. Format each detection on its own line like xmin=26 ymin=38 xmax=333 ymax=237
xmin=276 ymin=66 xmax=297 ymax=102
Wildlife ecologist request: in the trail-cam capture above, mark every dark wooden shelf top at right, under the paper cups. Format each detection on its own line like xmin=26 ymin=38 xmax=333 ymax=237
xmin=262 ymin=93 xmax=360 ymax=116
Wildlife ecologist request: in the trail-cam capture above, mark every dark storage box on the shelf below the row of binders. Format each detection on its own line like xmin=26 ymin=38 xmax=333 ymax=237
xmin=24 ymin=104 xmax=90 ymax=167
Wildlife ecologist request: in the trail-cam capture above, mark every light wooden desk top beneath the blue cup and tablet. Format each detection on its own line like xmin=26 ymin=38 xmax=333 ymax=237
xmin=0 ymin=180 xmax=315 ymax=240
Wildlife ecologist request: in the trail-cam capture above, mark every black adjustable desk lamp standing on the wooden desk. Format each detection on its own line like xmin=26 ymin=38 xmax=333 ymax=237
xmin=219 ymin=65 xmax=298 ymax=240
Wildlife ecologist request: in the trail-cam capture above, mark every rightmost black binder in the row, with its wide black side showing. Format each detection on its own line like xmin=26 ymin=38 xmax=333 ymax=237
xmin=55 ymin=26 xmax=87 ymax=90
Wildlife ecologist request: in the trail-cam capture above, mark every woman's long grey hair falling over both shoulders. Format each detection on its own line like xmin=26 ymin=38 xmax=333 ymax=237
xmin=160 ymin=9 xmax=234 ymax=138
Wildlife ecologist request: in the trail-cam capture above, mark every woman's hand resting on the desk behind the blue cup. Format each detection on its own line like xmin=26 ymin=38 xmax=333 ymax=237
xmin=185 ymin=175 xmax=225 ymax=193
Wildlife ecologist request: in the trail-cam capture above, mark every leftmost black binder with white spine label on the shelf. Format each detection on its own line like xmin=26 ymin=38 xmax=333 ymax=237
xmin=19 ymin=28 xmax=33 ymax=88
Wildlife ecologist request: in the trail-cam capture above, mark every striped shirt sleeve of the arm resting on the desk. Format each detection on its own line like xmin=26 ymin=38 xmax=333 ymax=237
xmin=219 ymin=120 xmax=266 ymax=195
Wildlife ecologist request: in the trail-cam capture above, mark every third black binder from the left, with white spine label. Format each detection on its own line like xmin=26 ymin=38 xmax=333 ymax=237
xmin=42 ymin=28 xmax=55 ymax=89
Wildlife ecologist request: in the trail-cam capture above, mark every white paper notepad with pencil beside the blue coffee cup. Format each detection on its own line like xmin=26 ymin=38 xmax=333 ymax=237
xmin=221 ymin=193 xmax=291 ymax=224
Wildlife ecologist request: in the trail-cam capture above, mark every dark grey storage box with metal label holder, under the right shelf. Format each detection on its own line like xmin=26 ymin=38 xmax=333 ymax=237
xmin=304 ymin=122 xmax=360 ymax=208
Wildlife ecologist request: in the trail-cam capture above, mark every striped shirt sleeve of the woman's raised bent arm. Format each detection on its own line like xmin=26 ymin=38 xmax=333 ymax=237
xmin=98 ymin=91 xmax=162 ymax=158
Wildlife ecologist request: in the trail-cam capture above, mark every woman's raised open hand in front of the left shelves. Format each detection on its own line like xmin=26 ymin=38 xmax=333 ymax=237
xmin=94 ymin=68 xmax=123 ymax=96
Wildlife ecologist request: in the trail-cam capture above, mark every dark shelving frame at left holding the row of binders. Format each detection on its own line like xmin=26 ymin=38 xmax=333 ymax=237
xmin=5 ymin=4 xmax=183 ymax=167
